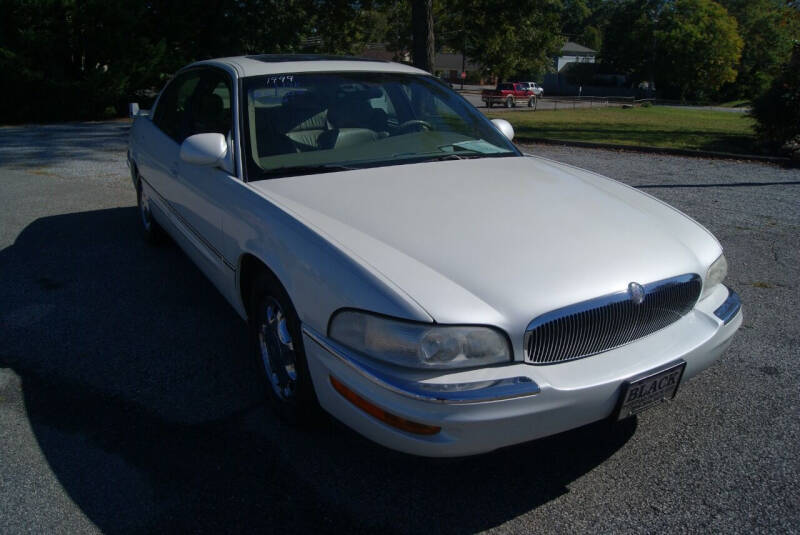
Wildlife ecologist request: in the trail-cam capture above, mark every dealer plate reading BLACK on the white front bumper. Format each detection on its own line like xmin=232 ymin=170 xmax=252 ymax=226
xmin=616 ymin=361 xmax=686 ymax=420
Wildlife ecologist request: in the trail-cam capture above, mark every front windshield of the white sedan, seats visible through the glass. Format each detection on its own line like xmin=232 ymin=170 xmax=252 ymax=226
xmin=242 ymin=72 xmax=519 ymax=180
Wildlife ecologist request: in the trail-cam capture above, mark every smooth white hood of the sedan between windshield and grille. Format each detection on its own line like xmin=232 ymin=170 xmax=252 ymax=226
xmin=251 ymin=157 xmax=721 ymax=340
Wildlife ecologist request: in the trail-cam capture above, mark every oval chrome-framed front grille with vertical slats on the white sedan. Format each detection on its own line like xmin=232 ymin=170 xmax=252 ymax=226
xmin=525 ymin=274 xmax=702 ymax=364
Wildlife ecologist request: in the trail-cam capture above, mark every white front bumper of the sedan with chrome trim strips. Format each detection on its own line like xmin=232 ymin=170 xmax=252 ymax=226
xmin=303 ymin=286 xmax=742 ymax=457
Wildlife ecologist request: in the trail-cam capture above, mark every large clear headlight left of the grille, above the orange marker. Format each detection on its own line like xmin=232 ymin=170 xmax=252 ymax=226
xmin=328 ymin=310 xmax=511 ymax=369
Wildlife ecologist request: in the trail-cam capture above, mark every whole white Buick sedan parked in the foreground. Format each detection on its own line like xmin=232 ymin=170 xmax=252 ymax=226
xmin=128 ymin=55 xmax=742 ymax=456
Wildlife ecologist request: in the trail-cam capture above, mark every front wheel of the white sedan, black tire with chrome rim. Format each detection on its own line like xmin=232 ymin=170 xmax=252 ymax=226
xmin=248 ymin=271 xmax=320 ymax=425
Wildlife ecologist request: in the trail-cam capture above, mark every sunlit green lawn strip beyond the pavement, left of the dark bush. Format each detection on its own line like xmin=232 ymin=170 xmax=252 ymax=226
xmin=488 ymin=106 xmax=759 ymax=154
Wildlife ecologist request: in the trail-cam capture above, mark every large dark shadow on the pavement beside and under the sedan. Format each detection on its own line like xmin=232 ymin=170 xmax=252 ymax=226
xmin=0 ymin=208 xmax=636 ymax=533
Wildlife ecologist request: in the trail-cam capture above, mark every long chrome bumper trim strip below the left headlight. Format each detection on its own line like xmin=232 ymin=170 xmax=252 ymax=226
xmin=303 ymin=325 xmax=540 ymax=405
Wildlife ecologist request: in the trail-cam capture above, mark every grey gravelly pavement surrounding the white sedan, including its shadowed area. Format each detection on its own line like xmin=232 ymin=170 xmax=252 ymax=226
xmin=0 ymin=122 xmax=800 ymax=533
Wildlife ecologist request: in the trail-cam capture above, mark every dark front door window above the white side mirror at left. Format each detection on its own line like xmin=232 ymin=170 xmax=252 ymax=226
xmin=188 ymin=71 xmax=232 ymax=136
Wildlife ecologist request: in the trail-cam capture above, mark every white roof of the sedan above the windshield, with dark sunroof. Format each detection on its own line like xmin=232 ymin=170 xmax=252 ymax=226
xmin=186 ymin=54 xmax=429 ymax=78
